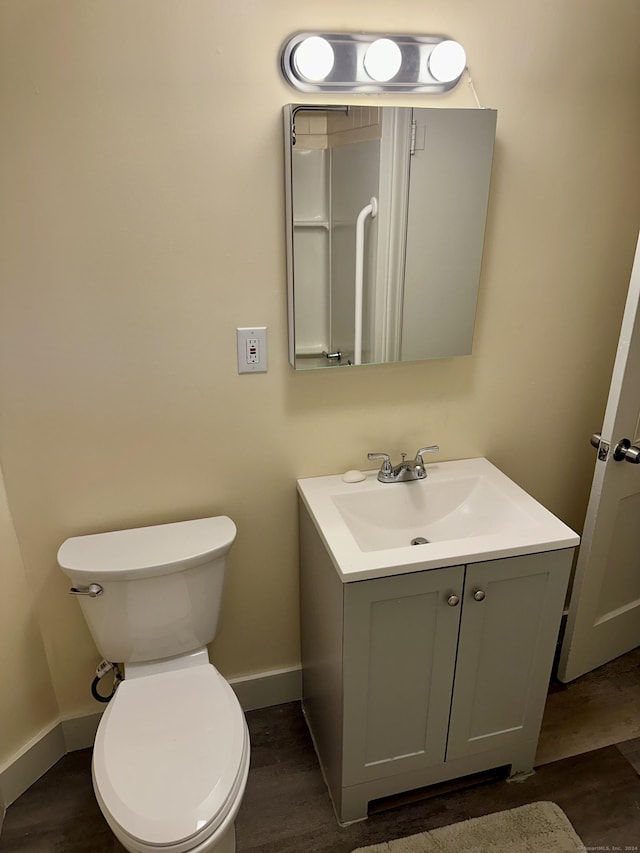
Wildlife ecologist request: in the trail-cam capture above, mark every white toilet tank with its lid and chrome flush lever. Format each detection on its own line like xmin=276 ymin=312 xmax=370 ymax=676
xmin=58 ymin=516 xmax=236 ymax=663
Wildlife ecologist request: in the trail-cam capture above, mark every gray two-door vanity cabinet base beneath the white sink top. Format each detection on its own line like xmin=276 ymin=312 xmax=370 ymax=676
xmin=300 ymin=506 xmax=573 ymax=823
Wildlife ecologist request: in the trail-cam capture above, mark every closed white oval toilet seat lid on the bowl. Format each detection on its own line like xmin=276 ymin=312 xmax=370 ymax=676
xmin=93 ymin=664 xmax=249 ymax=853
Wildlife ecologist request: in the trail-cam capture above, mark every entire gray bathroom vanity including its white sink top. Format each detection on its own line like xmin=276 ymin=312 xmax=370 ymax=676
xmin=298 ymin=459 xmax=579 ymax=823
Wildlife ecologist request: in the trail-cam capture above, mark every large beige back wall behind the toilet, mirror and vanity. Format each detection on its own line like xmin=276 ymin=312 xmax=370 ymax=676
xmin=0 ymin=0 xmax=640 ymax=748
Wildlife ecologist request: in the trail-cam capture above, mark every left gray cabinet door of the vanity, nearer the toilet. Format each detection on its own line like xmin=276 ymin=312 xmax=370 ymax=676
xmin=343 ymin=566 xmax=464 ymax=785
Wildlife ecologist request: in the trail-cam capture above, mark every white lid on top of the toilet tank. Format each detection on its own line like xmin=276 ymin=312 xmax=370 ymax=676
xmin=58 ymin=515 xmax=236 ymax=581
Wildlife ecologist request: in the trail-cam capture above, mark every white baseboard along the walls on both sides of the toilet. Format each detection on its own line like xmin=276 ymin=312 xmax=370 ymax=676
xmin=0 ymin=666 xmax=302 ymax=808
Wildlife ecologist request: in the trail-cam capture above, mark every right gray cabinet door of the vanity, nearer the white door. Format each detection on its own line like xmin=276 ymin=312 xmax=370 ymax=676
xmin=447 ymin=549 xmax=573 ymax=760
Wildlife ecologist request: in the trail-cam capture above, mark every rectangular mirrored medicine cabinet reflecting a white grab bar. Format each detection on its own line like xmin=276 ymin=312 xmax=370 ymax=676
xmin=284 ymin=104 xmax=497 ymax=369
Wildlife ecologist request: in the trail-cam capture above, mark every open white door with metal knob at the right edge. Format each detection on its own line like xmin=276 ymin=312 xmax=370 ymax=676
xmin=558 ymin=235 xmax=640 ymax=681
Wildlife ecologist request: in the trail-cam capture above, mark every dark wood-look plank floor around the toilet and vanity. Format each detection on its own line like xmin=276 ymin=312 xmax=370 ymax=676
xmin=0 ymin=650 xmax=640 ymax=853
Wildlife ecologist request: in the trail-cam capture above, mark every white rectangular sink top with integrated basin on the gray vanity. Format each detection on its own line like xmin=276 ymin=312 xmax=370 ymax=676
xmin=298 ymin=459 xmax=580 ymax=580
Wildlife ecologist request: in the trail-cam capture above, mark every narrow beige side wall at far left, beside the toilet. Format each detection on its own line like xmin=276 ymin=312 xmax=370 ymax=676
xmin=0 ymin=470 xmax=58 ymax=764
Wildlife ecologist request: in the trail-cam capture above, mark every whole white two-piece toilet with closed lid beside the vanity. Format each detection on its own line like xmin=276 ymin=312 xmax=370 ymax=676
xmin=58 ymin=516 xmax=249 ymax=853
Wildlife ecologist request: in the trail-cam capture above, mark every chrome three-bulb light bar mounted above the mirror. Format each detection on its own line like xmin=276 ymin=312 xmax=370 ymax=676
xmin=281 ymin=32 xmax=467 ymax=95
